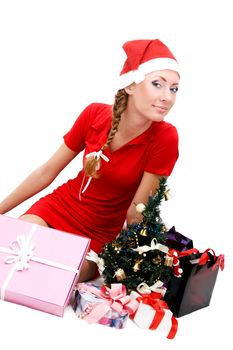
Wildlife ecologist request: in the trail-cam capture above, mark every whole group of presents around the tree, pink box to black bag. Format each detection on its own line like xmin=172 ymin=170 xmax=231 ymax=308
xmin=0 ymin=215 xmax=224 ymax=339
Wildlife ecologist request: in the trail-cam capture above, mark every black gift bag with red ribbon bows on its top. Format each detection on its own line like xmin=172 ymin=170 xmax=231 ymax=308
xmin=164 ymin=249 xmax=224 ymax=317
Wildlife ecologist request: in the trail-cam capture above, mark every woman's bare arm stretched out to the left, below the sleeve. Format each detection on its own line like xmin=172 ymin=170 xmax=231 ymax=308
xmin=0 ymin=144 xmax=77 ymax=214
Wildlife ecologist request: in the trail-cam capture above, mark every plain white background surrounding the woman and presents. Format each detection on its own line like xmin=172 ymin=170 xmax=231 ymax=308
xmin=0 ymin=0 xmax=230 ymax=350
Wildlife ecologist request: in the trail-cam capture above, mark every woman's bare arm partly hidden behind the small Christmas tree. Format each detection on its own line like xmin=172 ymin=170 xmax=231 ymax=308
xmin=126 ymin=172 xmax=161 ymax=224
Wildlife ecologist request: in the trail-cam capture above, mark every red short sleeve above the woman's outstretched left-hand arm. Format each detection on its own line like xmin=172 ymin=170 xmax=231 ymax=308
xmin=63 ymin=104 xmax=93 ymax=152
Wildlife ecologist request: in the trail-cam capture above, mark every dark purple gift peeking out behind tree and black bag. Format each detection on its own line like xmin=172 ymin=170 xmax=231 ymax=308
xmin=165 ymin=226 xmax=193 ymax=252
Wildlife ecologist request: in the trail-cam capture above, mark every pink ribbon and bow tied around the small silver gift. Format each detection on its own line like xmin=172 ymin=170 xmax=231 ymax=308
xmin=78 ymin=283 xmax=138 ymax=323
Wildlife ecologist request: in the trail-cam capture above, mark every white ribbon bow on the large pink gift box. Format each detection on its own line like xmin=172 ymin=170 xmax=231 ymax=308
xmin=4 ymin=235 xmax=35 ymax=271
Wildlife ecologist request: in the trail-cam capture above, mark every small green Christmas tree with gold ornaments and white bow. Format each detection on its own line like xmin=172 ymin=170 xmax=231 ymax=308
xmin=99 ymin=178 xmax=173 ymax=292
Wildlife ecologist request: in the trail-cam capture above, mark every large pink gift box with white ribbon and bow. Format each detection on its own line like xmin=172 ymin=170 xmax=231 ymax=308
xmin=0 ymin=215 xmax=90 ymax=316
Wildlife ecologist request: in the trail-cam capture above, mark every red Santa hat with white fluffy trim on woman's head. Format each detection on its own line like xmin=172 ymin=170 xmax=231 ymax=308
xmin=119 ymin=39 xmax=179 ymax=89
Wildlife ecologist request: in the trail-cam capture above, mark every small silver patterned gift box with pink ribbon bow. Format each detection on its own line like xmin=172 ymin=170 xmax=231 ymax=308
xmin=73 ymin=283 xmax=138 ymax=329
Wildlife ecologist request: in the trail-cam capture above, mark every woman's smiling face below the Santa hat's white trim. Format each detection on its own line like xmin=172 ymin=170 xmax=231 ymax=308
xmin=126 ymin=70 xmax=180 ymax=121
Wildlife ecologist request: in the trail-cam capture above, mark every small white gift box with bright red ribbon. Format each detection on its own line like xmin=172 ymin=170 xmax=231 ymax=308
xmin=130 ymin=291 xmax=178 ymax=339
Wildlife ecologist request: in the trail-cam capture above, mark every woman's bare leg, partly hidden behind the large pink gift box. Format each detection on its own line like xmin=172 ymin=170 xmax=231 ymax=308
xmin=20 ymin=214 xmax=96 ymax=282
